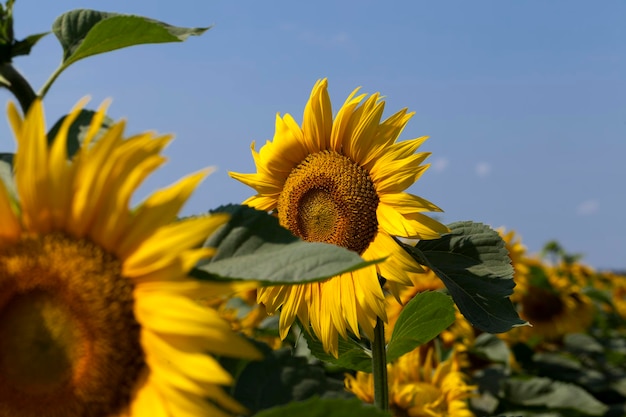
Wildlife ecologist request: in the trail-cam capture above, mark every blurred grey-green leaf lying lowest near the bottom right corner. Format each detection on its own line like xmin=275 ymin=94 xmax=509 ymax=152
xmin=502 ymin=378 xmax=608 ymax=416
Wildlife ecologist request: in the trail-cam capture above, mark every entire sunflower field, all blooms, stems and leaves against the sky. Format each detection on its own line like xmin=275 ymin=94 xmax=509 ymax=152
xmin=0 ymin=4 xmax=626 ymax=417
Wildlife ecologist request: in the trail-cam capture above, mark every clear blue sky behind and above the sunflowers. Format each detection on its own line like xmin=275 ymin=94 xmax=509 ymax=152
xmin=0 ymin=0 xmax=626 ymax=269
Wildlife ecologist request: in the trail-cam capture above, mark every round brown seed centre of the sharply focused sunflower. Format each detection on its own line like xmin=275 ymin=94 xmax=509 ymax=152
xmin=278 ymin=151 xmax=378 ymax=254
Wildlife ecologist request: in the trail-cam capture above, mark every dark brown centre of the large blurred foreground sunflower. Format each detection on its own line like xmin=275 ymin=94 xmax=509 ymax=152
xmin=0 ymin=234 xmax=145 ymax=417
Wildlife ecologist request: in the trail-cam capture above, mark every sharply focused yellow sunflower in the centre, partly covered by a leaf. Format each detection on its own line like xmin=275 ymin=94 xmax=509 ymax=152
xmin=230 ymin=79 xmax=448 ymax=356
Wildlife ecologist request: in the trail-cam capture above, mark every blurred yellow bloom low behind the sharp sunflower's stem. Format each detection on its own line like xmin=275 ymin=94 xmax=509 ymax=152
xmin=344 ymin=346 xmax=476 ymax=417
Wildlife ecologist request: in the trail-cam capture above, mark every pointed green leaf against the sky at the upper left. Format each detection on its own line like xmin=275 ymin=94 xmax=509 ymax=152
xmin=52 ymin=9 xmax=209 ymax=67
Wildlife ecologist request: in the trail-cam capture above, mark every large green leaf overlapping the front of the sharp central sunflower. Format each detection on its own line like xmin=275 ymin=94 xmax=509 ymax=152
xmin=191 ymin=205 xmax=377 ymax=285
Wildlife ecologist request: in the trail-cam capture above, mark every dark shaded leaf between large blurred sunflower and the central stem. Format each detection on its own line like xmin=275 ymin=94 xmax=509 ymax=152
xmin=220 ymin=342 xmax=352 ymax=413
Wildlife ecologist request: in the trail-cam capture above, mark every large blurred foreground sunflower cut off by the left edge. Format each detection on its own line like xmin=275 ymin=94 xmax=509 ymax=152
xmin=0 ymin=101 xmax=257 ymax=417
